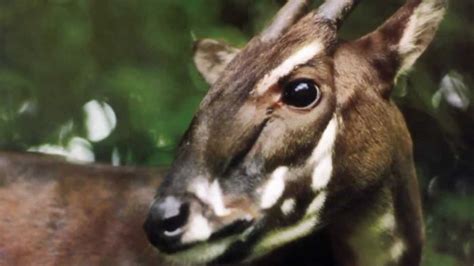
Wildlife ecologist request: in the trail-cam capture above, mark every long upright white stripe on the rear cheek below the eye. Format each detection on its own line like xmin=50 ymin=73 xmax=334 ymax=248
xmin=309 ymin=115 xmax=338 ymax=191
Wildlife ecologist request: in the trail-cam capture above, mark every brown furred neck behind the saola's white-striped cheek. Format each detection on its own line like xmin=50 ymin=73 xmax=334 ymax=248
xmin=328 ymin=39 xmax=423 ymax=265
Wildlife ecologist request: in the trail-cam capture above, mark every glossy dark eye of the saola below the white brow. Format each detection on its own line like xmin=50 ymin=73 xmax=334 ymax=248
xmin=282 ymin=79 xmax=321 ymax=108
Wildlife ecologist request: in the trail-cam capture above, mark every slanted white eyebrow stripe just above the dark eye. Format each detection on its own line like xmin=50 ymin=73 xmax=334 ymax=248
xmin=256 ymin=41 xmax=324 ymax=95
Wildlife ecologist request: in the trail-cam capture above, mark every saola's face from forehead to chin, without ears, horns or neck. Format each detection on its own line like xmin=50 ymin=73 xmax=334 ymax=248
xmin=146 ymin=18 xmax=337 ymax=261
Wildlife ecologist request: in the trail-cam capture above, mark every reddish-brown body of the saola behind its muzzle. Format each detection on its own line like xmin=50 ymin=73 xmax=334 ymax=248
xmin=0 ymin=153 xmax=162 ymax=266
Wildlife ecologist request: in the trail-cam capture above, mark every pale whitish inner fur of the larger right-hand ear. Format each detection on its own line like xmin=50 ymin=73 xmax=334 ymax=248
xmin=398 ymin=0 xmax=445 ymax=73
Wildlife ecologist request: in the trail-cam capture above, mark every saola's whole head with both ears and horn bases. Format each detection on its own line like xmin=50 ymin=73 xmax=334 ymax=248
xmin=145 ymin=0 xmax=444 ymax=263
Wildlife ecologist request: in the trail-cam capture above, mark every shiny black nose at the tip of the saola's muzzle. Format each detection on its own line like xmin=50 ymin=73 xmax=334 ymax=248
xmin=144 ymin=196 xmax=189 ymax=253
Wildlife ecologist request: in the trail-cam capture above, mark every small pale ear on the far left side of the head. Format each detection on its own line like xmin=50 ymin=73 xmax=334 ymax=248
xmin=194 ymin=39 xmax=239 ymax=85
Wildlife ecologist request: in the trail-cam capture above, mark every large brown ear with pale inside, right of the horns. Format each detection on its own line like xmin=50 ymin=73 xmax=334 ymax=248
xmin=358 ymin=0 xmax=447 ymax=79
